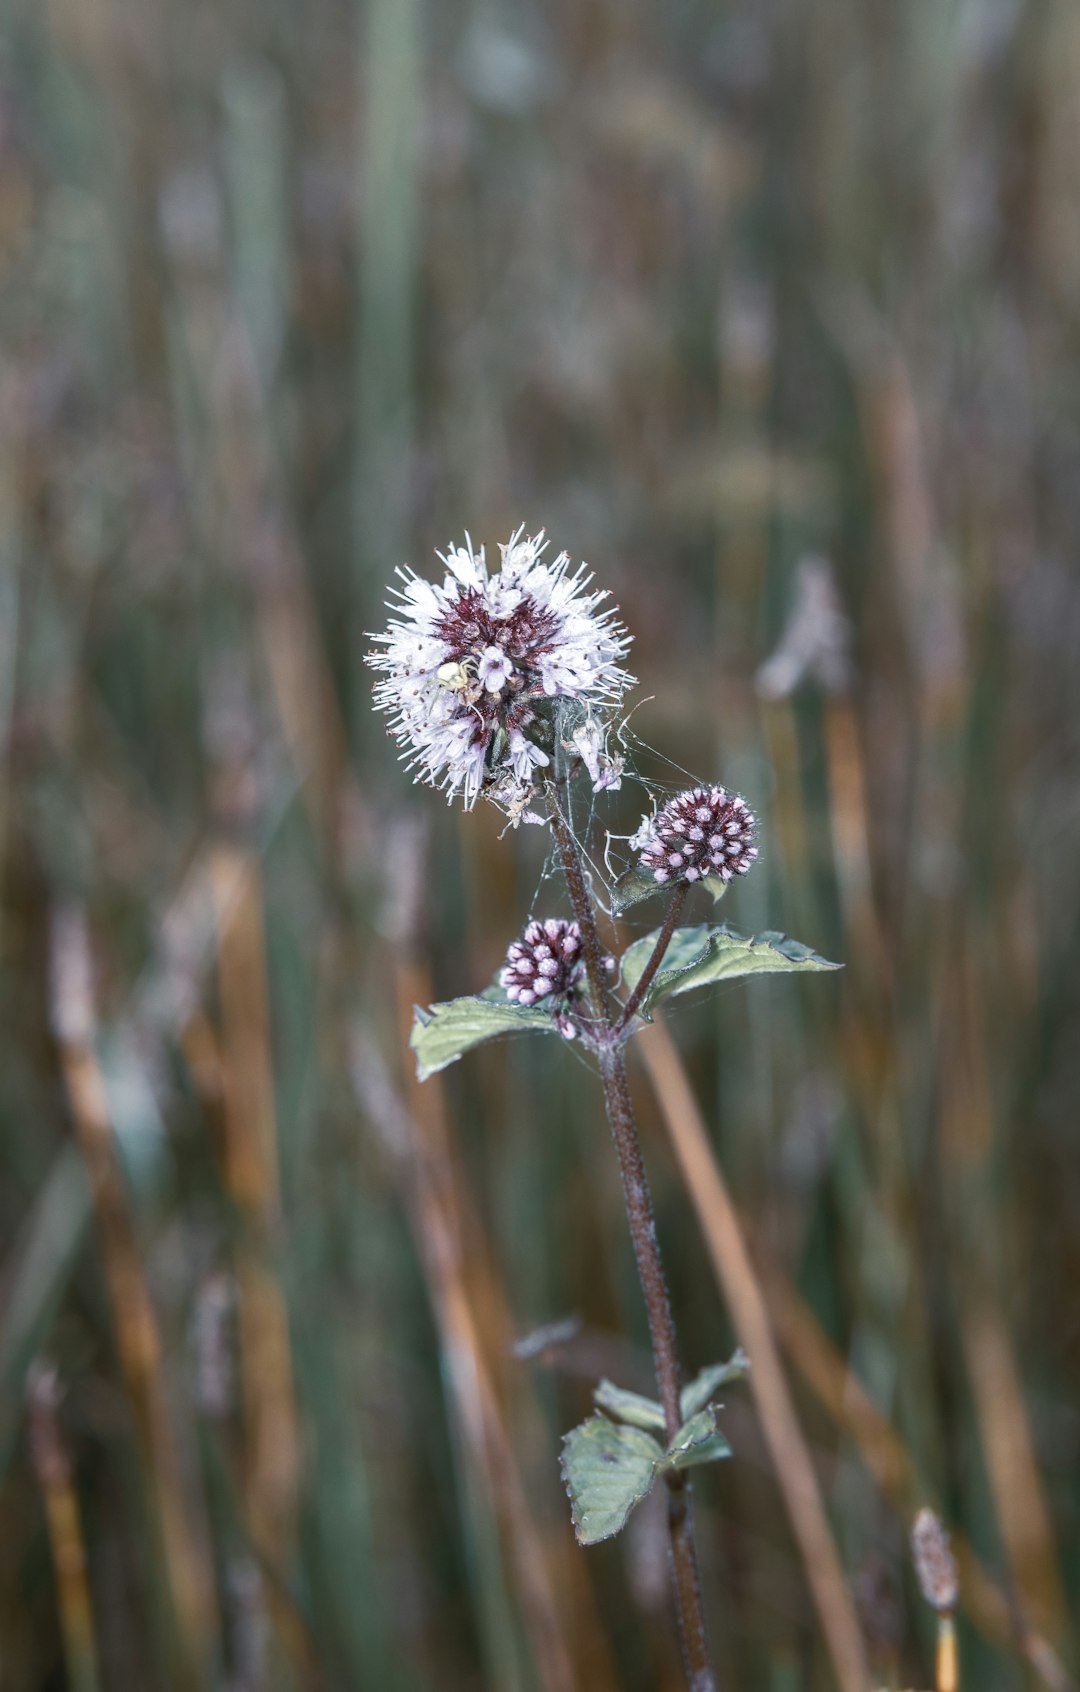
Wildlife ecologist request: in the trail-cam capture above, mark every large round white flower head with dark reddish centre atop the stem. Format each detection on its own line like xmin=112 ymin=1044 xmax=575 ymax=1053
xmin=367 ymin=530 xmax=633 ymax=822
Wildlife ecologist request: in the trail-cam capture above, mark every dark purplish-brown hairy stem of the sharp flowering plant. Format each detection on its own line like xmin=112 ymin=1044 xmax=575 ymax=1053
xmin=547 ymin=783 xmax=716 ymax=1692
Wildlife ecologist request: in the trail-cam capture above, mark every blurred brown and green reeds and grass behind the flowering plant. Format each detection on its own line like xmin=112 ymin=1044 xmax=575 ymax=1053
xmin=0 ymin=0 xmax=1080 ymax=1692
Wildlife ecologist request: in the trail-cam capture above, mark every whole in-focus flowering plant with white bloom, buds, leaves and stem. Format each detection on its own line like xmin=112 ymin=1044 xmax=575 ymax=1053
xmin=369 ymin=530 xmax=836 ymax=1692
